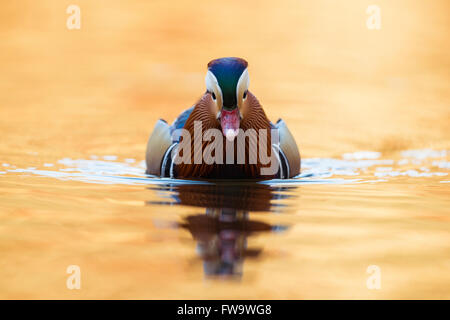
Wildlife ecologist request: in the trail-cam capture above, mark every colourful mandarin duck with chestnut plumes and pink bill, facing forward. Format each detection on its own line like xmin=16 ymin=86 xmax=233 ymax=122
xmin=145 ymin=57 xmax=301 ymax=180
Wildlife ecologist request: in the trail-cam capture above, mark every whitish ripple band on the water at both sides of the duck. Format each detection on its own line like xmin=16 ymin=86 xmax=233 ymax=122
xmin=0 ymin=149 xmax=450 ymax=186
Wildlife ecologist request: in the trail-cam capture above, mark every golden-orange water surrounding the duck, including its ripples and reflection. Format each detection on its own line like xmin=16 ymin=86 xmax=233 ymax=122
xmin=0 ymin=0 xmax=450 ymax=299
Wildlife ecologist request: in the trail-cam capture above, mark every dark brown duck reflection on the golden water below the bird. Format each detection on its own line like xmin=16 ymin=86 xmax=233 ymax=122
xmin=151 ymin=182 xmax=289 ymax=278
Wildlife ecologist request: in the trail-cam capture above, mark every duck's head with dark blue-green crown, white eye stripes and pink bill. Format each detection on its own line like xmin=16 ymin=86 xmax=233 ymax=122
xmin=205 ymin=58 xmax=249 ymax=141
